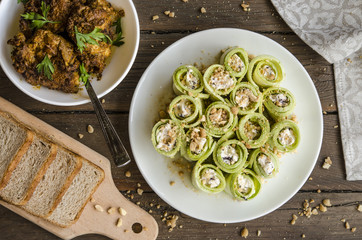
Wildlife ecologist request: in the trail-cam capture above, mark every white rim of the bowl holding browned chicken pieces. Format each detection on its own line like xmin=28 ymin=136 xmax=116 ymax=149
xmin=0 ymin=0 xmax=140 ymax=106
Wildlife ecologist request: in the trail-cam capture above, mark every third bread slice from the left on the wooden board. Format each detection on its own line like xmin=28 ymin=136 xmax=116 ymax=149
xmin=23 ymin=147 xmax=82 ymax=217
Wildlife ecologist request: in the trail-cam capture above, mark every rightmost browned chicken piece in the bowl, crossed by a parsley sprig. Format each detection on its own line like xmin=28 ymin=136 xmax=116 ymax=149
xmin=67 ymin=0 xmax=123 ymax=79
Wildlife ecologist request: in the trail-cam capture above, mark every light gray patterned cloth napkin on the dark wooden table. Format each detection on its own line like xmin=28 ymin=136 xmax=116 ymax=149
xmin=271 ymin=0 xmax=362 ymax=180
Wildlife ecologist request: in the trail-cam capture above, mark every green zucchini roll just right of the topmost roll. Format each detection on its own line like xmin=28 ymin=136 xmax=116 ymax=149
xmin=247 ymin=55 xmax=285 ymax=88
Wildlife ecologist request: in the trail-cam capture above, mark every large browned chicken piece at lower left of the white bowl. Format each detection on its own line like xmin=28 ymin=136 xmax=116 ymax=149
xmin=8 ymin=29 xmax=80 ymax=93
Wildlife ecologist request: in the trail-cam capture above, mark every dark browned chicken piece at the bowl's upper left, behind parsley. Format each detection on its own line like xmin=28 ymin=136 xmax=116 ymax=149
xmin=20 ymin=0 xmax=78 ymax=37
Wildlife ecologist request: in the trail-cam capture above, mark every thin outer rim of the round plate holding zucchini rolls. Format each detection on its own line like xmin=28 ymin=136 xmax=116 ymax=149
xmin=128 ymin=28 xmax=323 ymax=223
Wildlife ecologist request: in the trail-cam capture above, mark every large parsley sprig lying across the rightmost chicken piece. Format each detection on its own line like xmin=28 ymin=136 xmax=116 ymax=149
xmin=75 ymin=26 xmax=112 ymax=53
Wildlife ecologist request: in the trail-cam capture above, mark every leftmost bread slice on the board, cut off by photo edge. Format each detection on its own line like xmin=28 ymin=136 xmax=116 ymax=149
xmin=0 ymin=112 xmax=33 ymax=189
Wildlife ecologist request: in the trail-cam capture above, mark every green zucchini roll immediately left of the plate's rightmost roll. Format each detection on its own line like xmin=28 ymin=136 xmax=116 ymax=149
xmin=236 ymin=113 xmax=270 ymax=148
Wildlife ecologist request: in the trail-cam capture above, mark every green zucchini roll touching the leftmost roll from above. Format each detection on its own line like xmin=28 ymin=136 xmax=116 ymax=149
xmin=168 ymin=95 xmax=203 ymax=128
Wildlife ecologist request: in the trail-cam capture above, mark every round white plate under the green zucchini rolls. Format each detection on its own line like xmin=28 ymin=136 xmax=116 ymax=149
xmin=129 ymin=28 xmax=323 ymax=223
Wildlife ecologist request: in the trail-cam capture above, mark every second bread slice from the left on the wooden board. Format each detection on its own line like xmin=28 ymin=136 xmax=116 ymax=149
xmin=0 ymin=135 xmax=57 ymax=205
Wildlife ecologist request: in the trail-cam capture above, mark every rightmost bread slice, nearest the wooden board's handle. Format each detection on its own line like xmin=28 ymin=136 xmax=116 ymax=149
xmin=47 ymin=160 xmax=104 ymax=227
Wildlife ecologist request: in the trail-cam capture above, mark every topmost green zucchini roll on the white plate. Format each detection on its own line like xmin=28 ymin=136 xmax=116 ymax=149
xmin=220 ymin=47 xmax=249 ymax=79
